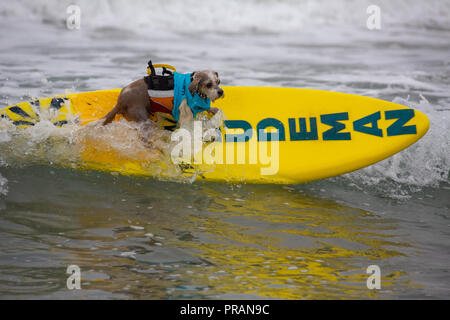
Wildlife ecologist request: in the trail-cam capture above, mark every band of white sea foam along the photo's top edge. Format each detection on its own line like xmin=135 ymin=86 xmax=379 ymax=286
xmin=0 ymin=0 xmax=450 ymax=32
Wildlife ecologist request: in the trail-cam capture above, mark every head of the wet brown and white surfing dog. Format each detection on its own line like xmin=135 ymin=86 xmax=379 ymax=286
xmin=189 ymin=70 xmax=223 ymax=101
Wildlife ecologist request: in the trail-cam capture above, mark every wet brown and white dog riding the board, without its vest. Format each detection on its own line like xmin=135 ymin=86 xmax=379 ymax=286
xmin=103 ymin=70 xmax=224 ymax=127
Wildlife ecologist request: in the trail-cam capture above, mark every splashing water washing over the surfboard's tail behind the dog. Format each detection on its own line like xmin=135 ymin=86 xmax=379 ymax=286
xmin=0 ymin=103 xmax=225 ymax=184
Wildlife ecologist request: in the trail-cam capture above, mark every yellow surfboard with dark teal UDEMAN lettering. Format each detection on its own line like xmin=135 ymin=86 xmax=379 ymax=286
xmin=0 ymin=87 xmax=429 ymax=184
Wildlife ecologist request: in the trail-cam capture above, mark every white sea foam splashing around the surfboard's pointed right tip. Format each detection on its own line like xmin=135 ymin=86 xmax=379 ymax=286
xmin=343 ymin=97 xmax=450 ymax=198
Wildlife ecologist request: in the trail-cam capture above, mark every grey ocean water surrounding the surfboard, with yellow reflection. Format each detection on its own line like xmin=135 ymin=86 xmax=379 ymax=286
xmin=0 ymin=0 xmax=450 ymax=299
